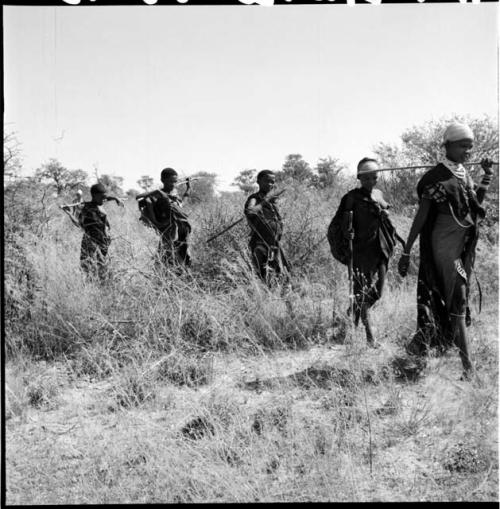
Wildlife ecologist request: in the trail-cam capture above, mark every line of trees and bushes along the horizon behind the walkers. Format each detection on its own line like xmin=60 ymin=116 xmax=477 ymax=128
xmin=4 ymin=115 xmax=499 ymax=241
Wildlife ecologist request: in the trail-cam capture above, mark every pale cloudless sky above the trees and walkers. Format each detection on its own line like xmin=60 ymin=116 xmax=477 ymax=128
xmin=3 ymin=2 xmax=499 ymax=189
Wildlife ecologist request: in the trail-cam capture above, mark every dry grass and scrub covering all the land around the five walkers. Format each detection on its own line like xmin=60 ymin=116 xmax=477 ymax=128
xmin=4 ymin=118 xmax=498 ymax=505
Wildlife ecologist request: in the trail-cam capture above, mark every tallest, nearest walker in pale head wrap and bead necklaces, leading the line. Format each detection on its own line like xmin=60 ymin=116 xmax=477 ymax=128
xmin=398 ymin=123 xmax=493 ymax=380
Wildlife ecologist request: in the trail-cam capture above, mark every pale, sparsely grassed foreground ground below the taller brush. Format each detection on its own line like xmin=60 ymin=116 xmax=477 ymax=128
xmin=6 ymin=312 xmax=498 ymax=504
